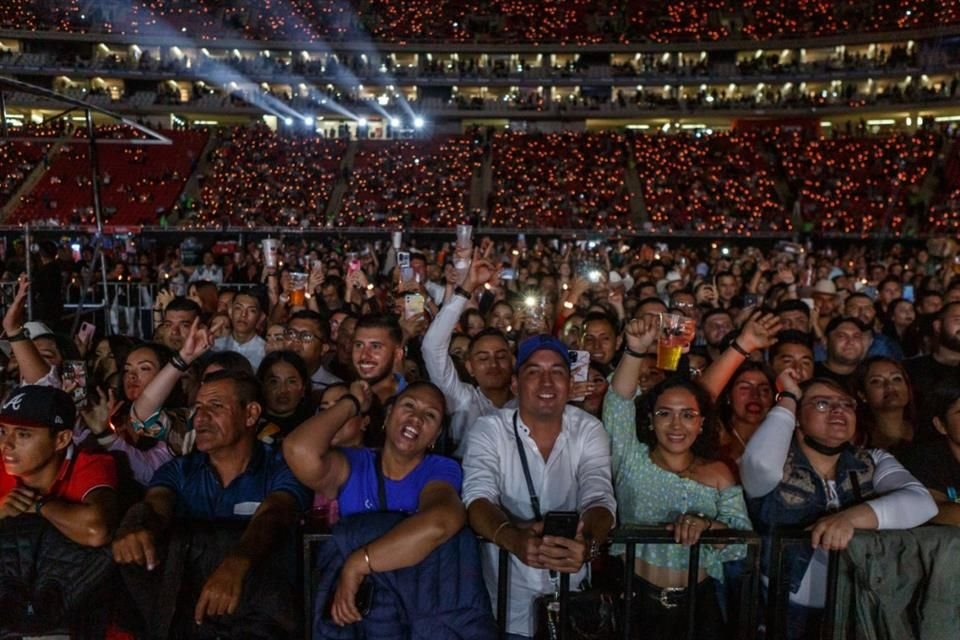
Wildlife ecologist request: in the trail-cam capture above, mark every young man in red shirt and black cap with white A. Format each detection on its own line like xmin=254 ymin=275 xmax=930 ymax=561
xmin=0 ymin=386 xmax=117 ymax=547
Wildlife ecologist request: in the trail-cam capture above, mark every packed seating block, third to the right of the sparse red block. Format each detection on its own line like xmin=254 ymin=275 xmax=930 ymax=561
xmin=484 ymin=132 xmax=630 ymax=229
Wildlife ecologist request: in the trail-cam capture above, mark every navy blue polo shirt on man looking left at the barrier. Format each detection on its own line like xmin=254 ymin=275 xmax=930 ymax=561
xmin=150 ymin=441 xmax=313 ymax=520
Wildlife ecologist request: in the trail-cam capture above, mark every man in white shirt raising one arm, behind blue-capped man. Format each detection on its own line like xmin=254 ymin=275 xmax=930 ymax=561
xmin=420 ymin=258 xmax=517 ymax=445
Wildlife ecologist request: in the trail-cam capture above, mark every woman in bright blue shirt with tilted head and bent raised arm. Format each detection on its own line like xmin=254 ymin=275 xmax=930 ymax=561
xmin=283 ymin=382 xmax=466 ymax=625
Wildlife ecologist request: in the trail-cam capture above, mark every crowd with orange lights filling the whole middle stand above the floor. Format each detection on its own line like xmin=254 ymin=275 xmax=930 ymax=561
xmin=7 ymin=121 xmax=960 ymax=235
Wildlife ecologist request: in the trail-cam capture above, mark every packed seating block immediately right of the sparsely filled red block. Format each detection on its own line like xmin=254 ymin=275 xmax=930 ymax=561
xmin=197 ymin=126 xmax=347 ymax=226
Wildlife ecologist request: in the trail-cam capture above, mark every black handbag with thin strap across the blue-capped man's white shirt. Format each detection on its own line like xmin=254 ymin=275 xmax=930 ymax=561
xmin=513 ymin=411 xmax=619 ymax=640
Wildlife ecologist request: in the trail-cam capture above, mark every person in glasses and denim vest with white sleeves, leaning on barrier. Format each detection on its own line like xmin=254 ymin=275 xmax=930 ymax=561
xmin=740 ymin=369 xmax=937 ymax=640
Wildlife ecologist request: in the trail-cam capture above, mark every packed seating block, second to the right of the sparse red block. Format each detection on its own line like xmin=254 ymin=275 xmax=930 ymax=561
xmin=337 ymin=136 xmax=482 ymax=228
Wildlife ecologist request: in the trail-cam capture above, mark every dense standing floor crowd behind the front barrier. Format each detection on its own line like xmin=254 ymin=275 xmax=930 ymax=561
xmin=0 ymin=229 xmax=960 ymax=640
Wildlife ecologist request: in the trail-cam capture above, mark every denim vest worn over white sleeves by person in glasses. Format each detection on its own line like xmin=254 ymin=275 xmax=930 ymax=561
xmin=747 ymin=440 xmax=875 ymax=593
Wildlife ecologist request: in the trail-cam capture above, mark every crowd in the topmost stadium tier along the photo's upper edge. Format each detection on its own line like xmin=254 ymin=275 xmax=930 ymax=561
xmin=0 ymin=0 xmax=960 ymax=45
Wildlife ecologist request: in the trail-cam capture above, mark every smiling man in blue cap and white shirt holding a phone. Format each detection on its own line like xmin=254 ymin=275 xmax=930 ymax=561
xmin=463 ymin=335 xmax=616 ymax=638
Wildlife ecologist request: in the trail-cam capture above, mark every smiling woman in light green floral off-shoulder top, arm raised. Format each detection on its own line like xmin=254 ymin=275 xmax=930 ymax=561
xmin=603 ymin=316 xmax=751 ymax=639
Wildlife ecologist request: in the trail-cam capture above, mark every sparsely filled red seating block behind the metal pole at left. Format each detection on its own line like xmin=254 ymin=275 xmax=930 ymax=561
xmin=10 ymin=126 xmax=208 ymax=225
